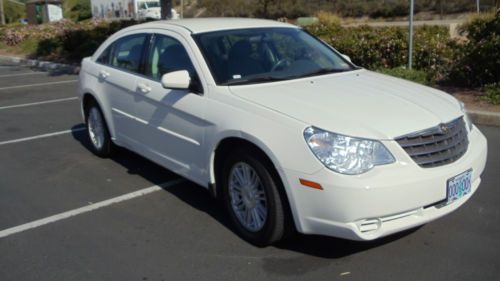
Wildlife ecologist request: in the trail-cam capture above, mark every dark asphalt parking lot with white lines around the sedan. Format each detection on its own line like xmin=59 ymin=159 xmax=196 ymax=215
xmin=0 ymin=66 xmax=500 ymax=281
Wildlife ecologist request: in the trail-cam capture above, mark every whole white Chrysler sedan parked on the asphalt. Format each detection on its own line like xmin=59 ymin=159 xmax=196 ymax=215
xmin=79 ymin=18 xmax=486 ymax=246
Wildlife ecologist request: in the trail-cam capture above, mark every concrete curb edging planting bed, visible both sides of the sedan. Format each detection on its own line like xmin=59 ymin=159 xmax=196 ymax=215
xmin=0 ymin=55 xmax=500 ymax=126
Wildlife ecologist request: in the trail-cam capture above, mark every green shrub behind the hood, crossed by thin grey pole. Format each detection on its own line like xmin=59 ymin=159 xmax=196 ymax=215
xmin=307 ymin=17 xmax=456 ymax=81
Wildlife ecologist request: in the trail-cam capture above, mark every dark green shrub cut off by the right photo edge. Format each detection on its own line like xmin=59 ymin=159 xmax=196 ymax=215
xmin=450 ymin=13 xmax=500 ymax=86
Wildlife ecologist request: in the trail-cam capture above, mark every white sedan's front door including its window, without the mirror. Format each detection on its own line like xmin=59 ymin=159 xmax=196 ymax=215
xmin=132 ymin=34 xmax=209 ymax=184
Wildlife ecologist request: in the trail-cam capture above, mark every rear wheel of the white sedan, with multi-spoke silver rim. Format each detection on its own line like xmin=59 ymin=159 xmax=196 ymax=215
xmin=85 ymin=102 xmax=113 ymax=158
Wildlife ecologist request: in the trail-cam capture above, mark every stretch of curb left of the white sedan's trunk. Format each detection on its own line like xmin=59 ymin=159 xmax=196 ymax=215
xmin=0 ymin=55 xmax=80 ymax=74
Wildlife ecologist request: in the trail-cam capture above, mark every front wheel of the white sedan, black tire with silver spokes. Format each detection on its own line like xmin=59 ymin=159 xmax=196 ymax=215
xmin=221 ymin=150 xmax=287 ymax=247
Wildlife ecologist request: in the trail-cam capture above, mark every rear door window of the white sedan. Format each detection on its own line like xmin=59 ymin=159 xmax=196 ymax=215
xmin=111 ymin=34 xmax=146 ymax=72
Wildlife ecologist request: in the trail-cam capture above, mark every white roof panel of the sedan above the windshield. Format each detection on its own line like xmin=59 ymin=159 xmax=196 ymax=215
xmin=140 ymin=18 xmax=298 ymax=33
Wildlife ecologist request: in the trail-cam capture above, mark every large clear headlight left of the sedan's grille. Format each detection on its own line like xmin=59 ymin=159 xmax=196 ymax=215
xmin=304 ymin=127 xmax=394 ymax=175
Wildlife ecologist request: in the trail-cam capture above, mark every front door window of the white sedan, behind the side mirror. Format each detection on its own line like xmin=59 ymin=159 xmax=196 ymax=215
xmin=146 ymin=35 xmax=196 ymax=80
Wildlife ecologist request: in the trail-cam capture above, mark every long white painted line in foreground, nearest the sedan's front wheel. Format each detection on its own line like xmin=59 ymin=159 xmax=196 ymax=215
xmin=0 ymin=179 xmax=185 ymax=238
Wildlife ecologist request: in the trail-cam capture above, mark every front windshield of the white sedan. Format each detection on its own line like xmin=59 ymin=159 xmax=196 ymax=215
xmin=194 ymin=28 xmax=357 ymax=85
